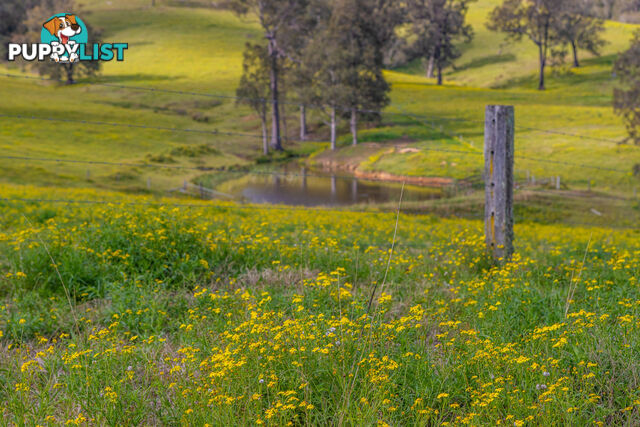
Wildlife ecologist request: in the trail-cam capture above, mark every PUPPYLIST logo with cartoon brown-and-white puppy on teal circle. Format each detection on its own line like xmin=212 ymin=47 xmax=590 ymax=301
xmin=8 ymin=13 xmax=129 ymax=64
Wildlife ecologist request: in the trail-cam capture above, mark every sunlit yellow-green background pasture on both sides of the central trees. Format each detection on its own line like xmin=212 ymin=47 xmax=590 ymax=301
xmin=0 ymin=0 xmax=640 ymax=195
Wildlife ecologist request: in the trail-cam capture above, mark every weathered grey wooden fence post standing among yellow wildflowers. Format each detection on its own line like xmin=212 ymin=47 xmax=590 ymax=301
xmin=484 ymin=105 xmax=515 ymax=260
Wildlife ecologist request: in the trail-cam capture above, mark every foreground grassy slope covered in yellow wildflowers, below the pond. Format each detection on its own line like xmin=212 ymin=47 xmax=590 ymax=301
xmin=0 ymin=185 xmax=640 ymax=425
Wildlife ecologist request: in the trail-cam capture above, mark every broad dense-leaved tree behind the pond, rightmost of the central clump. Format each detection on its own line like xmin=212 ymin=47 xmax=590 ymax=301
xmin=298 ymin=0 xmax=398 ymax=149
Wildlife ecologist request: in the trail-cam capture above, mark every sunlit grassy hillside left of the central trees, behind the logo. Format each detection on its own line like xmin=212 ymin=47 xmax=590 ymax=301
xmin=0 ymin=1 xmax=260 ymax=188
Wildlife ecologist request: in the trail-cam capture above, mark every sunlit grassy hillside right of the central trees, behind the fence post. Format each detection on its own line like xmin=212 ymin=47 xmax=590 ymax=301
xmin=320 ymin=0 xmax=640 ymax=194
